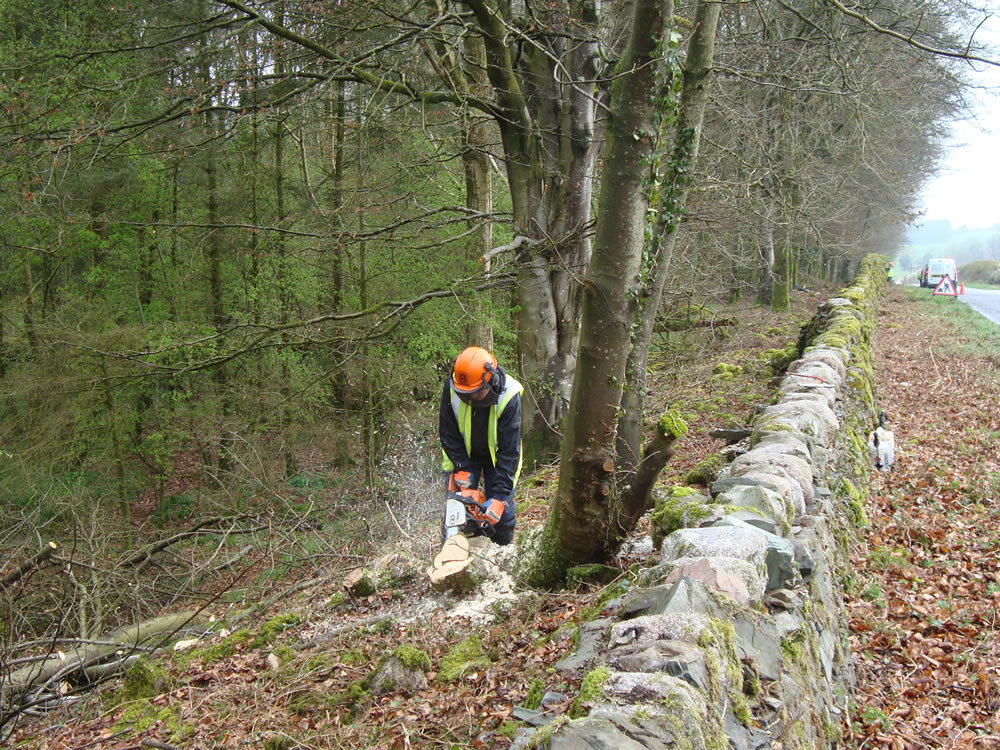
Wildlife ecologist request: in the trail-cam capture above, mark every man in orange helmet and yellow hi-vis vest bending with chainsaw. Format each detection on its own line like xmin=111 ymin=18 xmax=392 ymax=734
xmin=439 ymin=346 xmax=524 ymax=544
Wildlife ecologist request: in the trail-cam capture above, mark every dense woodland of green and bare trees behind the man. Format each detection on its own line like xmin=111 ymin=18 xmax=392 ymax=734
xmin=0 ymin=0 xmax=990 ymax=736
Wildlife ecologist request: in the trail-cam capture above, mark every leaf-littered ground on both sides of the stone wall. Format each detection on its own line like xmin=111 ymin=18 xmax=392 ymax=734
xmin=10 ymin=287 xmax=1000 ymax=750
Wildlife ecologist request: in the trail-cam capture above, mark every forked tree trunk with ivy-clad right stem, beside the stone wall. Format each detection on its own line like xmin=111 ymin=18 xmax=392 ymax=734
xmin=528 ymin=0 xmax=719 ymax=585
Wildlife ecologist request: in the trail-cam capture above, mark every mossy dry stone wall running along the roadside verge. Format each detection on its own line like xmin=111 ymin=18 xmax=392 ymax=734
xmin=513 ymin=256 xmax=886 ymax=750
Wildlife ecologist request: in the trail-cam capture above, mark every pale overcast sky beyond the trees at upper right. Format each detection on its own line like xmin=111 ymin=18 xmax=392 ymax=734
xmin=922 ymin=11 xmax=1000 ymax=228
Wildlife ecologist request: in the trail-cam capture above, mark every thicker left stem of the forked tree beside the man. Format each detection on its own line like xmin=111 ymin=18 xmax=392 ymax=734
xmin=530 ymin=0 xmax=673 ymax=585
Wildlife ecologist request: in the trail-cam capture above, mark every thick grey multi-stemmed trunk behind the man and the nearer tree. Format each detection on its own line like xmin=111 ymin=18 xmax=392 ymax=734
xmin=466 ymin=0 xmax=600 ymax=464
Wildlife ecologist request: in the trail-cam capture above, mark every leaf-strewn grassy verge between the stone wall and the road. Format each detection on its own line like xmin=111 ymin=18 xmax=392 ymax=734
xmin=846 ymin=287 xmax=1000 ymax=750
